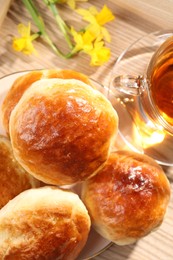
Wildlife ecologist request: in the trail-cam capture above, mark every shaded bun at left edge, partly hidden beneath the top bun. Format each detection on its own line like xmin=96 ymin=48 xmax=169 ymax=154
xmin=0 ymin=135 xmax=40 ymax=209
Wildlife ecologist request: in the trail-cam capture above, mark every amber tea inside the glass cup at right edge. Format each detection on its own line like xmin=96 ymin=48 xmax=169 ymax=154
xmin=147 ymin=37 xmax=173 ymax=126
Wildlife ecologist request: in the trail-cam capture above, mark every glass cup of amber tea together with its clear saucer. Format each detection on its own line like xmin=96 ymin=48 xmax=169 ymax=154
xmin=109 ymin=31 xmax=173 ymax=166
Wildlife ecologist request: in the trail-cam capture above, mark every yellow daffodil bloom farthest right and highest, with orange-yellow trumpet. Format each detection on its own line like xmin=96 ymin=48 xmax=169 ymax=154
xmin=77 ymin=5 xmax=115 ymax=42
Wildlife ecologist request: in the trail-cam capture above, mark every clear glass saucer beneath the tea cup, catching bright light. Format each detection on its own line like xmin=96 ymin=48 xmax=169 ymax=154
xmin=109 ymin=30 xmax=173 ymax=166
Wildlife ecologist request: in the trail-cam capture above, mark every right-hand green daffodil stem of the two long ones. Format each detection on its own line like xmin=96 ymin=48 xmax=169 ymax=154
xmin=43 ymin=0 xmax=73 ymax=49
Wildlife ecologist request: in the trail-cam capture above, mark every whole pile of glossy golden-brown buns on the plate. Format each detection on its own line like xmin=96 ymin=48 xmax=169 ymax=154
xmin=0 ymin=70 xmax=170 ymax=260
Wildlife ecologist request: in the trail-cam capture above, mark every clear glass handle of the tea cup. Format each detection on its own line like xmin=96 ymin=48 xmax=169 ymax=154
xmin=112 ymin=75 xmax=146 ymax=96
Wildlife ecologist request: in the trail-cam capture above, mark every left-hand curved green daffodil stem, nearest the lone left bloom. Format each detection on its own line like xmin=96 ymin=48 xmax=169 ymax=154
xmin=22 ymin=0 xmax=69 ymax=58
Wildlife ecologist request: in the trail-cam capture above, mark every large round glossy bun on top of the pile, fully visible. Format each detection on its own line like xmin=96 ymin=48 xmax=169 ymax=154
xmin=10 ymin=79 xmax=118 ymax=185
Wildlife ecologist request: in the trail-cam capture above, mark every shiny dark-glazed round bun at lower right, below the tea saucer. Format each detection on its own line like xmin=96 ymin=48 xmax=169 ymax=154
xmin=82 ymin=151 xmax=170 ymax=245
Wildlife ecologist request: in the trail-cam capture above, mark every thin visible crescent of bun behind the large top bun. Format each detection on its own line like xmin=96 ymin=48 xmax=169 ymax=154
xmin=2 ymin=69 xmax=91 ymax=134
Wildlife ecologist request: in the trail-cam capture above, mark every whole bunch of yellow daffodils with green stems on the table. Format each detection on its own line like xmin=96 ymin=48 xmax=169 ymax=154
xmin=13 ymin=0 xmax=115 ymax=66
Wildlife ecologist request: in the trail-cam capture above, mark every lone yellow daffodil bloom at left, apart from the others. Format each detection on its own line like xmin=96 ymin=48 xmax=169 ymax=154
xmin=12 ymin=23 xmax=38 ymax=55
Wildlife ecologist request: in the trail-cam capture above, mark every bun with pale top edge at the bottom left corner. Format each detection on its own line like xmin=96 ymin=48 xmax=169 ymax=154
xmin=0 ymin=187 xmax=90 ymax=260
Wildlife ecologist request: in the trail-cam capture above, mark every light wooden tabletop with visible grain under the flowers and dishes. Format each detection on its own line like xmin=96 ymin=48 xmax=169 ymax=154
xmin=0 ymin=0 xmax=173 ymax=260
